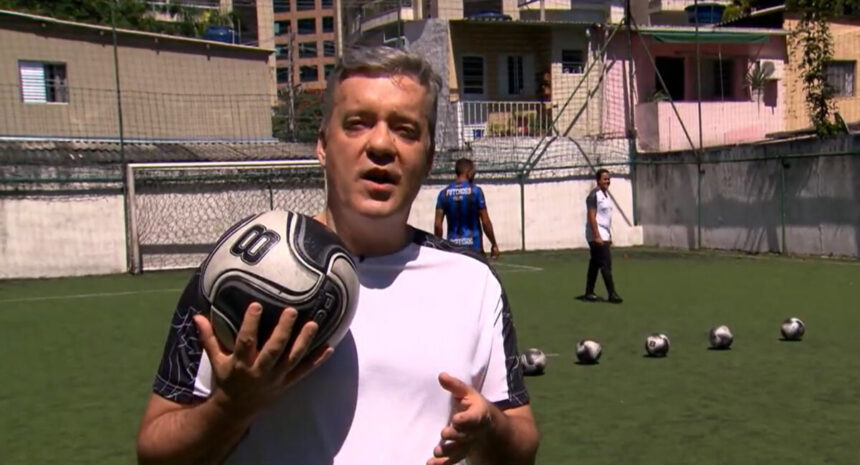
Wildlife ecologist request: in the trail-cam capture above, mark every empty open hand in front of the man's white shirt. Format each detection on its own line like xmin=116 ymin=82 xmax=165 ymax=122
xmin=427 ymin=370 xmax=498 ymax=465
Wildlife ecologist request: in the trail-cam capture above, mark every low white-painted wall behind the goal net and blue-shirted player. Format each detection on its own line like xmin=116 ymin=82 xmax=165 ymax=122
xmin=0 ymin=175 xmax=642 ymax=279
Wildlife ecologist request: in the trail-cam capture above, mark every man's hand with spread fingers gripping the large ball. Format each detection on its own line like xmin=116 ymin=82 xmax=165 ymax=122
xmin=194 ymin=302 xmax=334 ymax=413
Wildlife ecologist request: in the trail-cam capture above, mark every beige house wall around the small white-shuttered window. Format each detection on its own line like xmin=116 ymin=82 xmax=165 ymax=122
xmin=0 ymin=15 xmax=272 ymax=140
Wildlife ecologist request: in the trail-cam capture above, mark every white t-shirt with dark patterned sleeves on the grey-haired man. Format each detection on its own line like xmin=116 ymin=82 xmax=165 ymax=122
xmin=154 ymin=231 xmax=528 ymax=465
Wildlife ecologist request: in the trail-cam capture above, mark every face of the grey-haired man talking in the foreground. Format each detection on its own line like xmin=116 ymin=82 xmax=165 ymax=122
xmin=317 ymin=75 xmax=432 ymax=218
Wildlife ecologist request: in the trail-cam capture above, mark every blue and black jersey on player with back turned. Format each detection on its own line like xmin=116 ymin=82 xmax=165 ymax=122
xmin=436 ymin=181 xmax=487 ymax=251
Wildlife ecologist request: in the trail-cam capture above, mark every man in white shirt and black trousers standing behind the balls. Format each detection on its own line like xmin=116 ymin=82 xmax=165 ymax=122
xmin=578 ymin=169 xmax=623 ymax=304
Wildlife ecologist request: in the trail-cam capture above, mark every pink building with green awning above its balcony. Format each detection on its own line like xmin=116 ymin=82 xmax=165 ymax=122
xmin=604 ymin=27 xmax=786 ymax=152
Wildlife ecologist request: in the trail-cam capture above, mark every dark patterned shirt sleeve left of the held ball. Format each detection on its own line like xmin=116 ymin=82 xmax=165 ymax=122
xmin=152 ymin=271 xmax=209 ymax=404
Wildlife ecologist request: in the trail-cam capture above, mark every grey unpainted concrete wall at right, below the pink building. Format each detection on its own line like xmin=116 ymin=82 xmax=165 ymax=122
xmin=635 ymin=136 xmax=860 ymax=257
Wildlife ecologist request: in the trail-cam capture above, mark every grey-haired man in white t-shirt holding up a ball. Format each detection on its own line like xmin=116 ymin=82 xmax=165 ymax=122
xmin=137 ymin=47 xmax=538 ymax=465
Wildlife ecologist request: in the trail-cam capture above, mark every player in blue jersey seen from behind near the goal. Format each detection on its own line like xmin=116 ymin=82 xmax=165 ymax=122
xmin=434 ymin=158 xmax=499 ymax=258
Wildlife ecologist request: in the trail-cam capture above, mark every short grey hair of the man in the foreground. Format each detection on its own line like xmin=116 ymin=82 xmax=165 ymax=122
xmin=320 ymin=46 xmax=442 ymax=151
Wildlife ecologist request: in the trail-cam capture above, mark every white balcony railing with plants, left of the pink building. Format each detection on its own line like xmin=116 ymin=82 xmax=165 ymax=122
xmin=454 ymin=101 xmax=552 ymax=146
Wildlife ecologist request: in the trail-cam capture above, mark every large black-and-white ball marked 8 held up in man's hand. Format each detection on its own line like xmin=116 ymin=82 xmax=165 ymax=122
xmin=200 ymin=210 xmax=359 ymax=353
